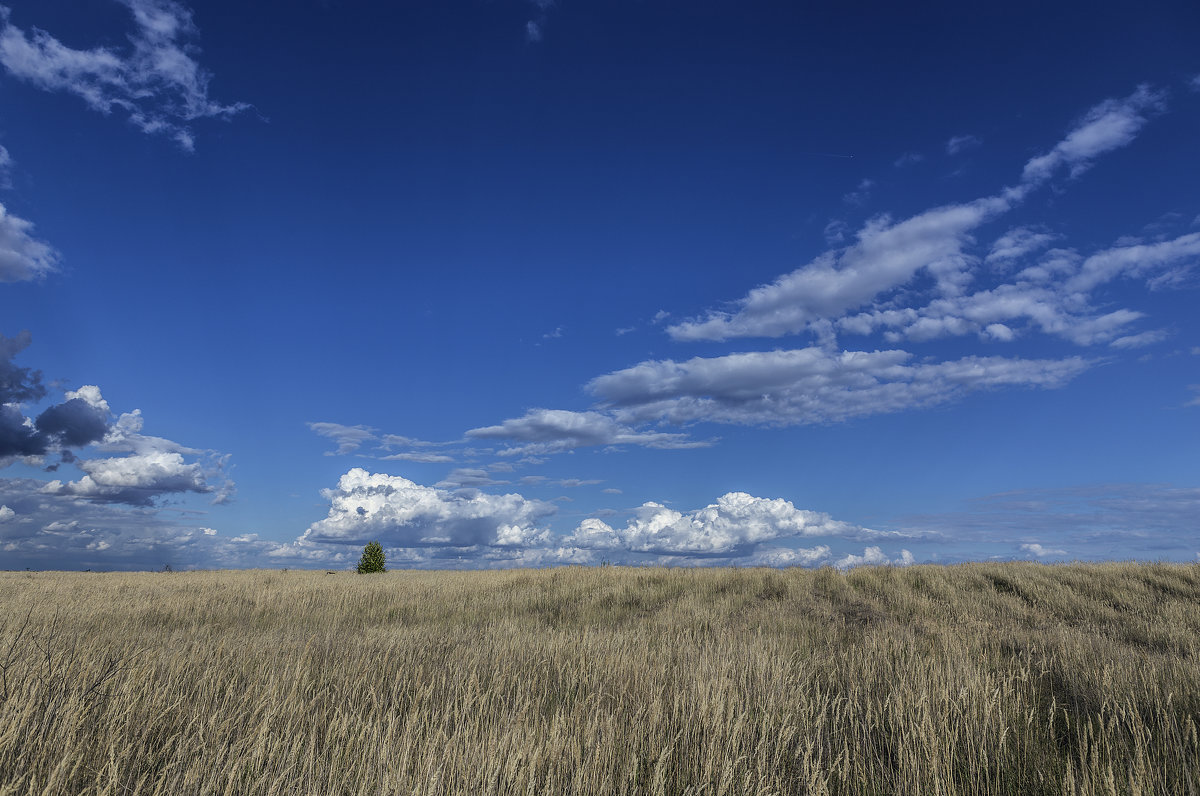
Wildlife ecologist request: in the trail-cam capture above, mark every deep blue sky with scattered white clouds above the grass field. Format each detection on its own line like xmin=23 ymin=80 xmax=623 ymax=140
xmin=0 ymin=0 xmax=1200 ymax=570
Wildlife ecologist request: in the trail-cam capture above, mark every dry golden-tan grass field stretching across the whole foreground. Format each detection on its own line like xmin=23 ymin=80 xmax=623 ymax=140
xmin=0 ymin=563 xmax=1200 ymax=796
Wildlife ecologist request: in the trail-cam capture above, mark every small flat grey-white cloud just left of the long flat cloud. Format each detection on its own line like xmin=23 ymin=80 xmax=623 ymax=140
xmin=467 ymin=409 xmax=712 ymax=456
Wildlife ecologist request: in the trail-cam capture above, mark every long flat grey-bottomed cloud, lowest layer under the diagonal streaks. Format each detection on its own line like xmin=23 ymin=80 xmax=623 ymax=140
xmin=588 ymin=348 xmax=1090 ymax=426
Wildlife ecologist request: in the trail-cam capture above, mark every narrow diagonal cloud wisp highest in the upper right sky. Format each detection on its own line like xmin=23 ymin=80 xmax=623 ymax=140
xmin=1021 ymin=85 xmax=1166 ymax=185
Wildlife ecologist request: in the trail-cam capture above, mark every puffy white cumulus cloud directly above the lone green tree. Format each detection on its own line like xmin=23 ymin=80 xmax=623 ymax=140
xmin=296 ymin=468 xmax=556 ymax=549
